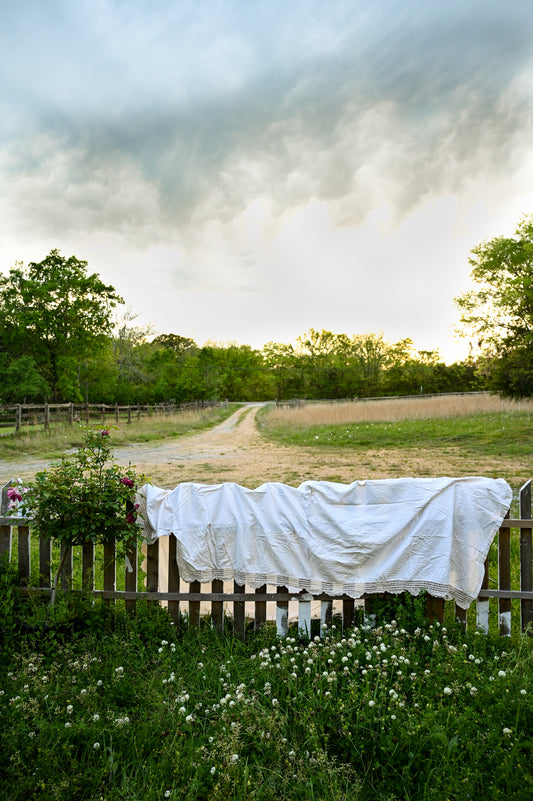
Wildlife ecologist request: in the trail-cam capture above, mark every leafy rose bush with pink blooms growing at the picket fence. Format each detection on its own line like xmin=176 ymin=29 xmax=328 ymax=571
xmin=19 ymin=429 xmax=146 ymax=545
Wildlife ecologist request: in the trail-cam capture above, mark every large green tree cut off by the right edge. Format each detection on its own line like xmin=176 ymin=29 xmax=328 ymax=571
xmin=456 ymin=215 xmax=533 ymax=395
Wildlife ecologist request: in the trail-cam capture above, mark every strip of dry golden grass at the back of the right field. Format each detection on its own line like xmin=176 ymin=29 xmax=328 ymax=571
xmin=268 ymin=394 xmax=533 ymax=427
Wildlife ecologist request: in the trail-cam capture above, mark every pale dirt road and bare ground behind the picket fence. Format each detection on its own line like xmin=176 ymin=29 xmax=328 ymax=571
xmin=0 ymin=403 xmax=528 ymax=489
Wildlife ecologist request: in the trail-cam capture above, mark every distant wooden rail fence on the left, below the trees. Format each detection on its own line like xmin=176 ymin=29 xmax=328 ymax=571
xmin=0 ymin=401 xmax=218 ymax=431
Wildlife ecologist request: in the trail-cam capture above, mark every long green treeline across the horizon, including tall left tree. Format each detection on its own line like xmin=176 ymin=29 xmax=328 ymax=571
xmin=0 ymin=250 xmax=486 ymax=405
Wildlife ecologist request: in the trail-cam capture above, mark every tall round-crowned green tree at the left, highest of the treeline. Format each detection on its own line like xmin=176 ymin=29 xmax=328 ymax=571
xmin=0 ymin=250 xmax=124 ymax=400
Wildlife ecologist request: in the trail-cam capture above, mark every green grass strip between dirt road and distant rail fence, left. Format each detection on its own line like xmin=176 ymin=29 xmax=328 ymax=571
xmin=0 ymin=404 xmax=238 ymax=461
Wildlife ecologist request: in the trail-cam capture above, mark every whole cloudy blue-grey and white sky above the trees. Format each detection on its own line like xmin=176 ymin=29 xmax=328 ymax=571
xmin=0 ymin=0 xmax=533 ymax=362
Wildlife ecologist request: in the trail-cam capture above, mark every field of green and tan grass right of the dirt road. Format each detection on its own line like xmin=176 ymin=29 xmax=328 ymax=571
xmin=260 ymin=395 xmax=533 ymax=466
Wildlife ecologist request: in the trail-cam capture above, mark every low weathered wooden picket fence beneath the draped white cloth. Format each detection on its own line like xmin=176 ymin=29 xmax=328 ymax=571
xmin=0 ymin=481 xmax=533 ymax=638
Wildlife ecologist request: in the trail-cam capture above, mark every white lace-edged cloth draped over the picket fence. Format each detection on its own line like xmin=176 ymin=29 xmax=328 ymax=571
xmin=137 ymin=477 xmax=512 ymax=608
